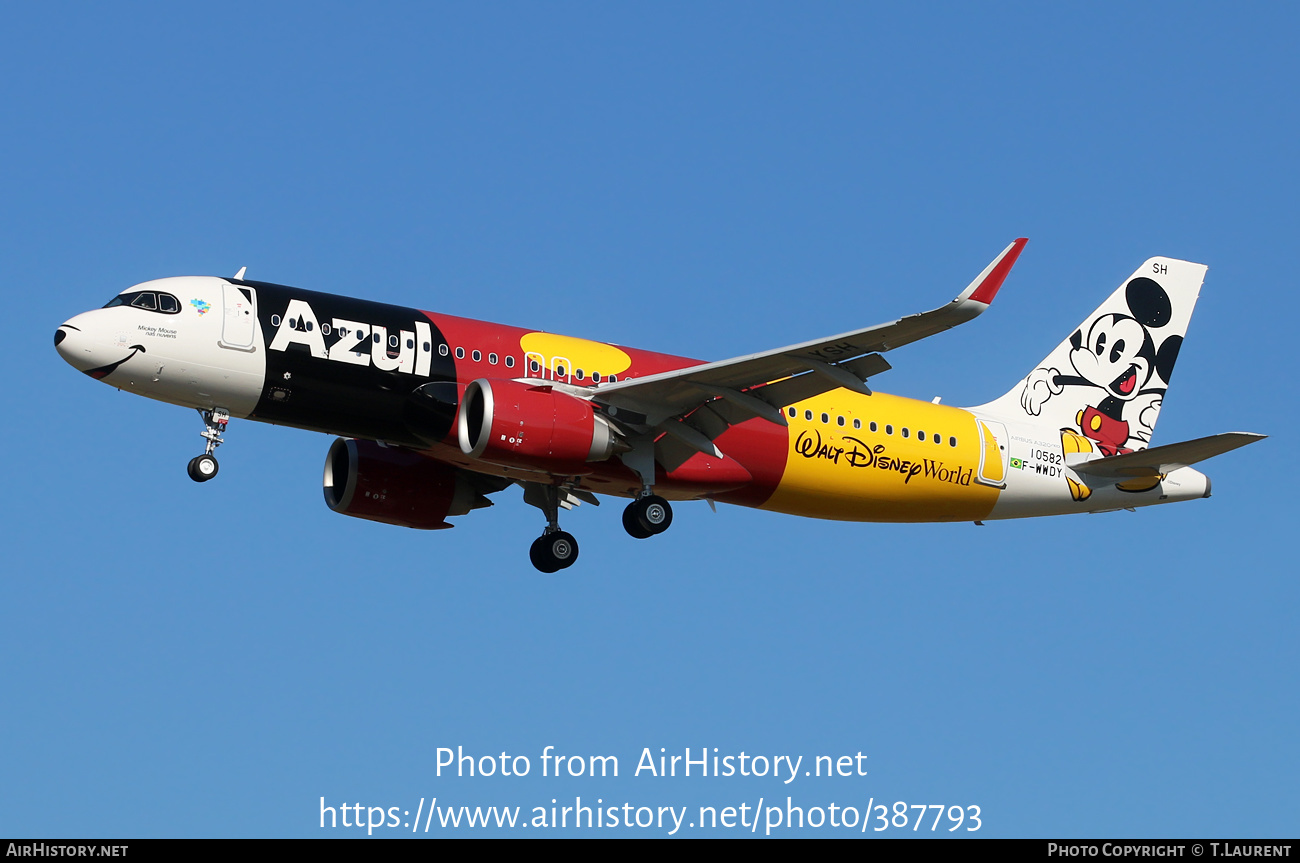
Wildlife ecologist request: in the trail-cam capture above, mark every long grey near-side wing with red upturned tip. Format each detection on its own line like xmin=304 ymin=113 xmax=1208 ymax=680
xmin=595 ymin=238 xmax=1028 ymax=460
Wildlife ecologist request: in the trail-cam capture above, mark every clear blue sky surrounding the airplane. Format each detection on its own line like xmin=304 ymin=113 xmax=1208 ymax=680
xmin=0 ymin=3 xmax=1300 ymax=837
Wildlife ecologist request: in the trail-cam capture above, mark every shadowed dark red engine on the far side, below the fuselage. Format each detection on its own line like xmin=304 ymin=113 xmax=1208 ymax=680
xmin=324 ymin=438 xmax=488 ymax=530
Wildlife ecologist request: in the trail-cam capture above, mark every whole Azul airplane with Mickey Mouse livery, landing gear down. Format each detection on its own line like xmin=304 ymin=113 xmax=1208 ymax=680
xmin=55 ymin=238 xmax=1265 ymax=573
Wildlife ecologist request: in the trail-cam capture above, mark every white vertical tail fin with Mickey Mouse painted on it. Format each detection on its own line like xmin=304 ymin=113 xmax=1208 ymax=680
xmin=974 ymin=257 xmax=1206 ymax=455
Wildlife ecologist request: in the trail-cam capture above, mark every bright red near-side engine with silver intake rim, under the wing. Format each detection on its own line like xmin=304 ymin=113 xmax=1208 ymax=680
xmin=456 ymin=378 xmax=621 ymax=473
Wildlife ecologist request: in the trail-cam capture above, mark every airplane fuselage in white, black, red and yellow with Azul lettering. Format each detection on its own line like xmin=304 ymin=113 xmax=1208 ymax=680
xmin=56 ymin=277 xmax=1209 ymax=521
